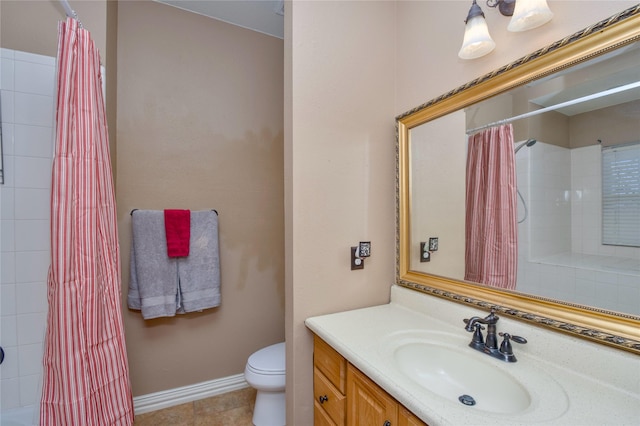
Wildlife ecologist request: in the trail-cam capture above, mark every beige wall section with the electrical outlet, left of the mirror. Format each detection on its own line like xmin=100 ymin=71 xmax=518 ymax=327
xmin=285 ymin=1 xmax=396 ymax=425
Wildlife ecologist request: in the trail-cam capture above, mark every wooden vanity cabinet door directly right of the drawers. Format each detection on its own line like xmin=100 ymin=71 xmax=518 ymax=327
xmin=347 ymin=364 xmax=398 ymax=426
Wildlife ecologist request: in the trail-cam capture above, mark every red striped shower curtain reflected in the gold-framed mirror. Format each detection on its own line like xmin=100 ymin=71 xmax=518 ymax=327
xmin=464 ymin=124 xmax=518 ymax=289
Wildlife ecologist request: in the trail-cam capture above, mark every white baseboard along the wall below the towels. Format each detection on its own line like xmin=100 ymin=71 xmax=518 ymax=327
xmin=133 ymin=374 xmax=249 ymax=414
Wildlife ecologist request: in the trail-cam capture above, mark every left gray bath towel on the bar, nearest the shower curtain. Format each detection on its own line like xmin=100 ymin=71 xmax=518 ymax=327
xmin=127 ymin=210 xmax=180 ymax=319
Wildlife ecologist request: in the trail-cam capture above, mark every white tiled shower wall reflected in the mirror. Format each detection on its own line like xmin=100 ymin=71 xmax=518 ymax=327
xmin=516 ymin=142 xmax=640 ymax=315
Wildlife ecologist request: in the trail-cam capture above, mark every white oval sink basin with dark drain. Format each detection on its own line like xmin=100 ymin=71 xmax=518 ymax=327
xmin=394 ymin=342 xmax=531 ymax=413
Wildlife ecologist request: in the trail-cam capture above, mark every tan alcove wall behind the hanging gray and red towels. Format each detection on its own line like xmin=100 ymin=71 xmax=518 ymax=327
xmin=117 ymin=1 xmax=284 ymax=395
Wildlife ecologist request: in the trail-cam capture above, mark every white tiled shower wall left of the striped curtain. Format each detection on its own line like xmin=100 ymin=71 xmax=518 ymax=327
xmin=0 ymin=49 xmax=55 ymax=412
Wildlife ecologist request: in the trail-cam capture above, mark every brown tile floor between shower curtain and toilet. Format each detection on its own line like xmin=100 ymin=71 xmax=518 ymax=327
xmin=134 ymin=388 xmax=256 ymax=426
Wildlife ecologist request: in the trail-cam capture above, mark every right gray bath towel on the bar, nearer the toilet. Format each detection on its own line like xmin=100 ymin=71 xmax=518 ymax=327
xmin=178 ymin=210 xmax=220 ymax=312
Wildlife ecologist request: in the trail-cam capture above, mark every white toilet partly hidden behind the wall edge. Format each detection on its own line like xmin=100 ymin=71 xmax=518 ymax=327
xmin=244 ymin=342 xmax=286 ymax=426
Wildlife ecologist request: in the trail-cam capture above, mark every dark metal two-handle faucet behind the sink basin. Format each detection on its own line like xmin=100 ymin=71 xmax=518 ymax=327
xmin=463 ymin=309 xmax=527 ymax=362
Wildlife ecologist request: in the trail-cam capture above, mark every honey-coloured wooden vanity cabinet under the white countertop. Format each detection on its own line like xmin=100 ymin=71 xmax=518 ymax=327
xmin=313 ymin=335 xmax=426 ymax=426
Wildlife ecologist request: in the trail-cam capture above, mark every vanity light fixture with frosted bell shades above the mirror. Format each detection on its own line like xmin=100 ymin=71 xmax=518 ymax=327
xmin=458 ymin=0 xmax=553 ymax=59
